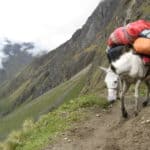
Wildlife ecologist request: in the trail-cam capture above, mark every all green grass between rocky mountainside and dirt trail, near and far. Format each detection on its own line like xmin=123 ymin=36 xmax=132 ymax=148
xmin=0 ymin=64 xmax=107 ymax=150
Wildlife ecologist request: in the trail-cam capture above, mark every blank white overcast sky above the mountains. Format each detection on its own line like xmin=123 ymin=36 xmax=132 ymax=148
xmin=0 ymin=0 xmax=100 ymax=50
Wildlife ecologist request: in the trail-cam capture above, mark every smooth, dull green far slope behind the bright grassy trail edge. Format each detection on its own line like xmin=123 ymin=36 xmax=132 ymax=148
xmin=0 ymin=66 xmax=86 ymax=139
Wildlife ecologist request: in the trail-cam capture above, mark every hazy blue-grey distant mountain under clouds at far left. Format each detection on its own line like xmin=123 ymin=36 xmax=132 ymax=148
xmin=0 ymin=40 xmax=41 ymax=84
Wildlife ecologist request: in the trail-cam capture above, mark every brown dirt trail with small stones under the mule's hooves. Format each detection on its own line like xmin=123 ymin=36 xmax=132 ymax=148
xmin=45 ymin=101 xmax=150 ymax=150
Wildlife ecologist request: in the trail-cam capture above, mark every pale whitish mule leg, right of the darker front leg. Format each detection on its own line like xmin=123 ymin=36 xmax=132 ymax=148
xmin=134 ymin=80 xmax=141 ymax=116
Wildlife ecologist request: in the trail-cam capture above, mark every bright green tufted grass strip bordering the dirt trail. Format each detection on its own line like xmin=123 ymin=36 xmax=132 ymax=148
xmin=0 ymin=95 xmax=108 ymax=150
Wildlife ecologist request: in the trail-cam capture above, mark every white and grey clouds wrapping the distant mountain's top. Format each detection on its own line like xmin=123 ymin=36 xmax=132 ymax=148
xmin=0 ymin=39 xmax=47 ymax=69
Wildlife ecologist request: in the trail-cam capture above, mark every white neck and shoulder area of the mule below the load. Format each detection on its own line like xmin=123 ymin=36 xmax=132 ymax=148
xmin=110 ymin=49 xmax=149 ymax=78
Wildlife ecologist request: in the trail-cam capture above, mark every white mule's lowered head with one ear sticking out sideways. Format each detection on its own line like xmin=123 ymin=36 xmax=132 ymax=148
xmin=100 ymin=67 xmax=120 ymax=101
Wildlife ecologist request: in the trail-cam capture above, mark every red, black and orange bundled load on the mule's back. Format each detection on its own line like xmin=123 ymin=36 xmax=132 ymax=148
xmin=106 ymin=20 xmax=150 ymax=65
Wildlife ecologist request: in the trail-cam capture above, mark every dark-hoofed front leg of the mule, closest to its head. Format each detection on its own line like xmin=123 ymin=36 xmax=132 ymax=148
xmin=120 ymin=81 xmax=130 ymax=118
